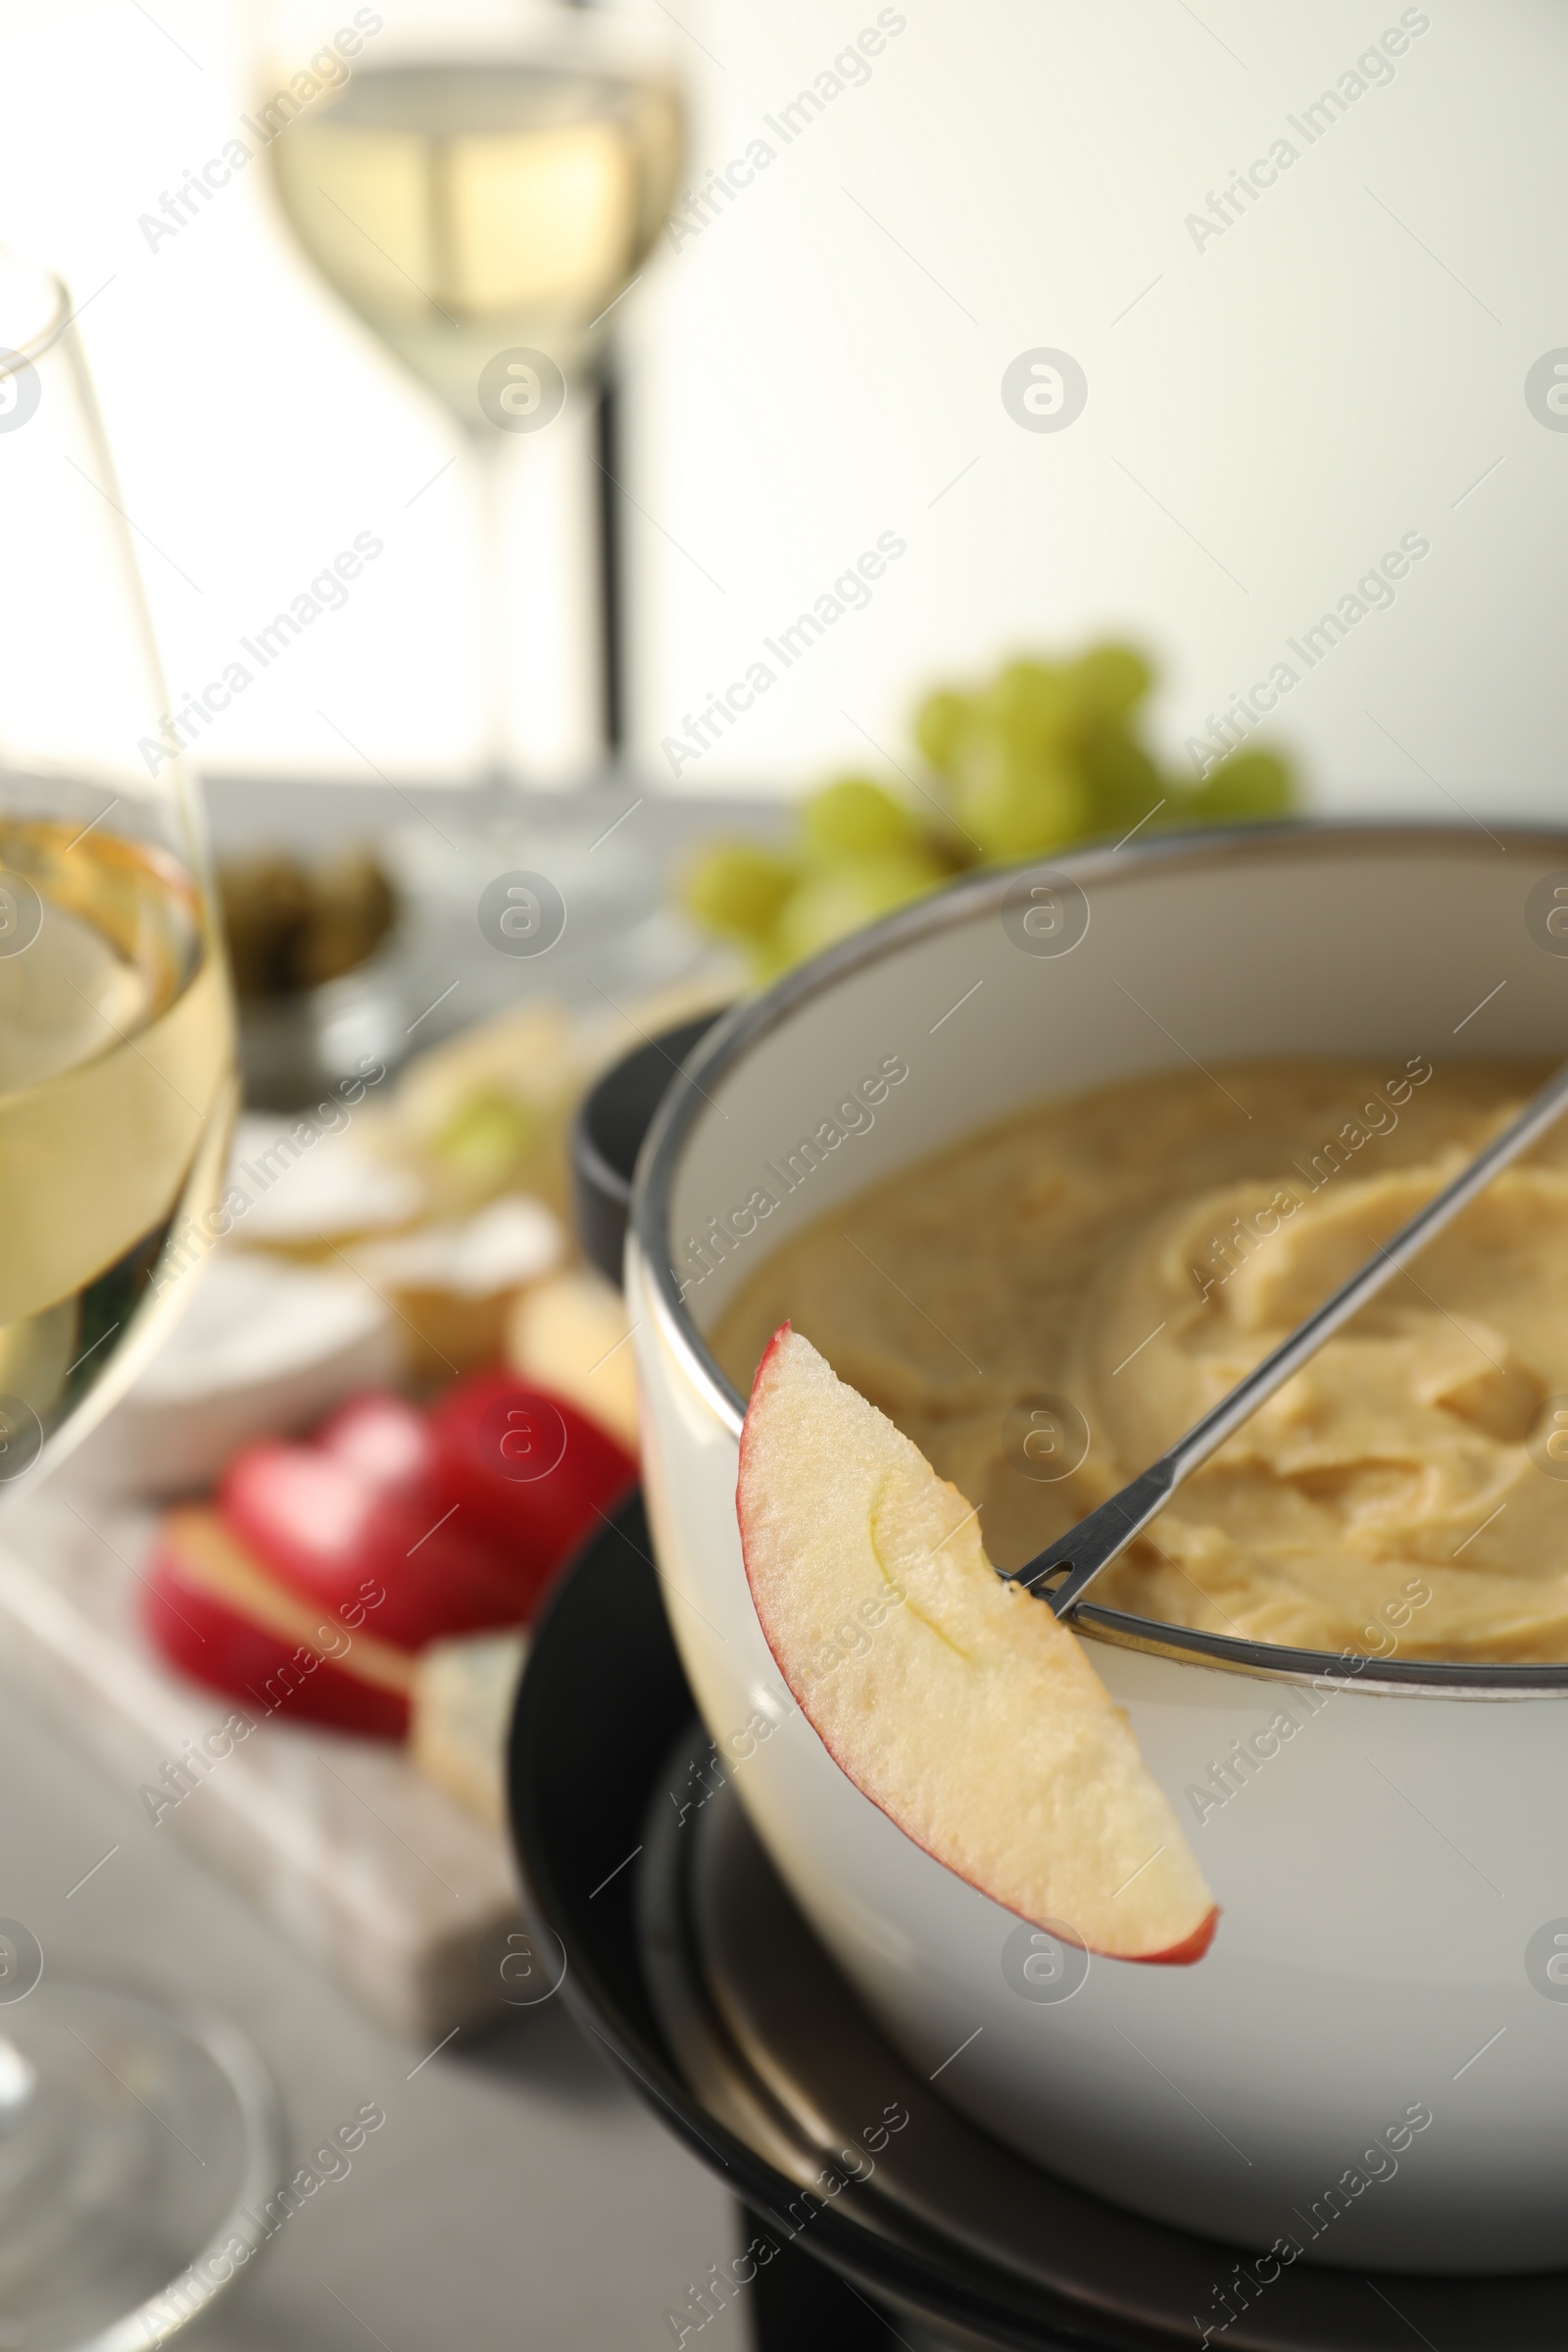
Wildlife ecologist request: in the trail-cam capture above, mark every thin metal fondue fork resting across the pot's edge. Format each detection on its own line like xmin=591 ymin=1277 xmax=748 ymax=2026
xmin=1020 ymin=1063 xmax=1568 ymax=1618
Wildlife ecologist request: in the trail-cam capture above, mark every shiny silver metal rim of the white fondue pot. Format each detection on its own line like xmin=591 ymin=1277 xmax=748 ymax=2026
xmin=630 ymin=816 xmax=1568 ymax=1700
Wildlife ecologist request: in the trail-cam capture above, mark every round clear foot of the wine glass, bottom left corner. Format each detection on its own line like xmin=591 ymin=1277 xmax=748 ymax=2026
xmin=0 ymin=1978 xmax=282 ymax=2352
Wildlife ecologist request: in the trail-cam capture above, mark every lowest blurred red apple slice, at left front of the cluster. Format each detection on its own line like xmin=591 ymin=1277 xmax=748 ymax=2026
xmin=141 ymin=1543 xmax=409 ymax=1740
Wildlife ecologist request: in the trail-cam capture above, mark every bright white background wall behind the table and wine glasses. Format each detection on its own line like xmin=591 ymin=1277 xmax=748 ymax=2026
xmin=0 ymin=0 xmax=1568 ymax=813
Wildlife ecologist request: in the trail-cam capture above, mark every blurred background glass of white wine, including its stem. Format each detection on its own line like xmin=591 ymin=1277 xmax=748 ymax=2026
xmin=252 ymin=0 xmax=684 ymax=781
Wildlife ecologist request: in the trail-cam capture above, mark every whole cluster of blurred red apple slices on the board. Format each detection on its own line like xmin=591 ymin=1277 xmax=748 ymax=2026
xmin=141 ymin=1371 xmax=637 ymax=1740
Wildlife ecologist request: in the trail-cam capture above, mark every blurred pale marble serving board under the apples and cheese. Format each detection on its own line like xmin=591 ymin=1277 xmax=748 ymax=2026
xmin=0 ymin=1475 xmax=522 ymax=2046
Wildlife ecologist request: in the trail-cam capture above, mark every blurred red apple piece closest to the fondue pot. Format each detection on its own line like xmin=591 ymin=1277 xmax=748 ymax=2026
xmin=430 ymin=1371 xmax=637 ymax=1606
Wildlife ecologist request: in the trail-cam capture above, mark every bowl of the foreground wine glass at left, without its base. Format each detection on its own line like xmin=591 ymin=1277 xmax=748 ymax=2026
xmin=0 ymin=257 xmax=235 ymax=1482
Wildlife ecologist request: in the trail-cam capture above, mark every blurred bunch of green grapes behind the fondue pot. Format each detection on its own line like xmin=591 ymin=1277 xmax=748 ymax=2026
xmin=684 ymin=645 xmax=1291 ymax=981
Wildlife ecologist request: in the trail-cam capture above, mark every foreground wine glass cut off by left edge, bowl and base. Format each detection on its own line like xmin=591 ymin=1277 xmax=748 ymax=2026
xmin=0 ymin=254 xmax=279 ymax=2352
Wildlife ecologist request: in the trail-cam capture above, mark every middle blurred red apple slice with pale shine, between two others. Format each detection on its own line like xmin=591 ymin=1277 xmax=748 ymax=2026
xmin=217 ymin=1442 xmax=531 ymax=1648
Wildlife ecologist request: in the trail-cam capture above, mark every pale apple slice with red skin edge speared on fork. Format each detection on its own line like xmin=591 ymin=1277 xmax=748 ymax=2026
xmin=736 ymin=1324 xmax=1218 ymax=1962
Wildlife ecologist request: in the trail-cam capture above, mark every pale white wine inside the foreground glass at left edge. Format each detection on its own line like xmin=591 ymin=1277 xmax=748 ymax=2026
xmin=0 ymin=823 xmax=232 ymax=1448
